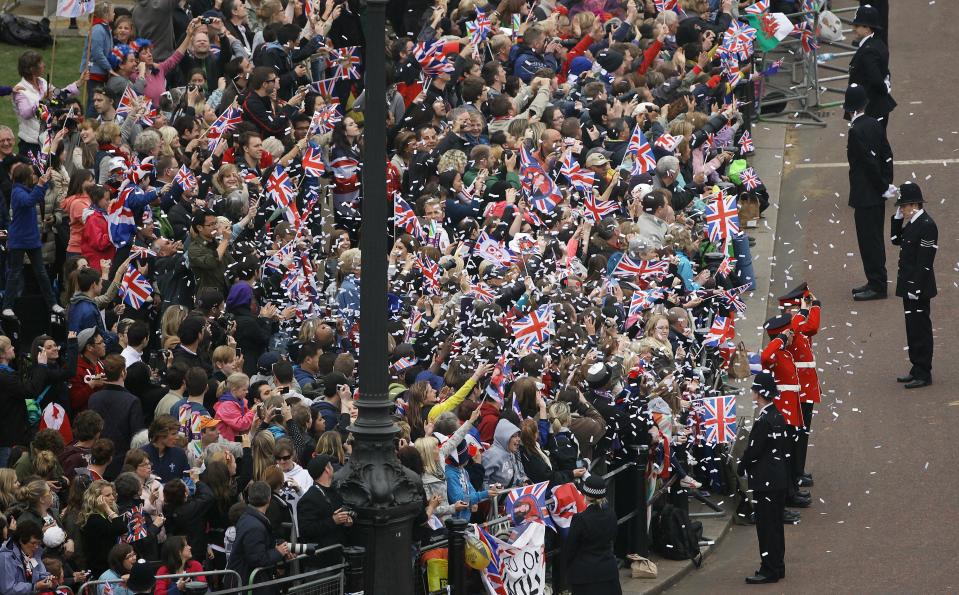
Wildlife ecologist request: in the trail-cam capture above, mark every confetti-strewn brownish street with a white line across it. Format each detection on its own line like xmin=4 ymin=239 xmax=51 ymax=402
xmin=669 ymin=0 xmax=959 ymax=593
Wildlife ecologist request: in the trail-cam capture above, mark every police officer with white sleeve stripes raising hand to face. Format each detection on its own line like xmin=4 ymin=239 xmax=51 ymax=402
xmin=891 ymin=182 xmax=939 ymax=388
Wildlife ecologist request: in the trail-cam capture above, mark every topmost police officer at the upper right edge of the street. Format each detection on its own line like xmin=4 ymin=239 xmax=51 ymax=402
xmin=849 ymin=6 xmax=896 ymax=129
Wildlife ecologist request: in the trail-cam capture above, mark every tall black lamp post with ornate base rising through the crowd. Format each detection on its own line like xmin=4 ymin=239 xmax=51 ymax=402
xmin=335 ymin=0 xmax=423 ymax=595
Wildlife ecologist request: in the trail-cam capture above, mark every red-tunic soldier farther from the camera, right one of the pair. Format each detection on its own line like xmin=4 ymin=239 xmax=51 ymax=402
xmin=779 ymin=283 xmax=822 ymax=487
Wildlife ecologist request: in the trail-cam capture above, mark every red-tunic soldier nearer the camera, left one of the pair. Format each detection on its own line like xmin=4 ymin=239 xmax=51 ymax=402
xmin=761 ymin=314 xmax=812 ymax=508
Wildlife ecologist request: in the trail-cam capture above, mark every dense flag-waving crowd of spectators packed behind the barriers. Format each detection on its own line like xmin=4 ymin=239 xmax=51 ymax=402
xmin=0 ymin=0 xmax=832 ymax=595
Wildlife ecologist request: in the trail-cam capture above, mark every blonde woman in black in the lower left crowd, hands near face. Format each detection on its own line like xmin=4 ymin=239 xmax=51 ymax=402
xmin=77 ymin=479 xmax=127 ymax=576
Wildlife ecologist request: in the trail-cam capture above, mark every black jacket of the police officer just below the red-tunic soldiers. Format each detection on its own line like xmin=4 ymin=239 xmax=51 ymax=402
xmin=739 ymin=403 xmax=789 ymax=492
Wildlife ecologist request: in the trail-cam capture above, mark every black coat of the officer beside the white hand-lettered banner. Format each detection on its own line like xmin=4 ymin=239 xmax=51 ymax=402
xmin=562 ymin=504 xmax=619 ymax=595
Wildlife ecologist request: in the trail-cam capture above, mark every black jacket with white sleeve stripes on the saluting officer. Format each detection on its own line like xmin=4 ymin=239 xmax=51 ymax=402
xmin=891 ymin=211 xmax=939 ymax=300
